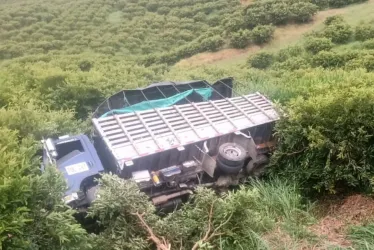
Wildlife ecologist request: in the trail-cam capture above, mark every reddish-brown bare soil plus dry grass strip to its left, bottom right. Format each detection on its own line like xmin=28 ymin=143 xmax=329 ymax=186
xmin=262 ymin=194 xmax=374 ymax=250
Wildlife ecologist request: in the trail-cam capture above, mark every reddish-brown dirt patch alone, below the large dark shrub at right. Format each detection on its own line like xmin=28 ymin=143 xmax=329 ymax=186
xmin=310 ymin=195 xmax=374 ymax=247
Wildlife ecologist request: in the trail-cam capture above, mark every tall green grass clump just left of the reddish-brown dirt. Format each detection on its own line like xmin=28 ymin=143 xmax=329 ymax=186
xmin=243 ymin=178 xmax=316 ymax=249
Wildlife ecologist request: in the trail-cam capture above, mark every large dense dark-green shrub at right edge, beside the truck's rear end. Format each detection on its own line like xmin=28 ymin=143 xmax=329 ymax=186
xmin=271 ymin=86 xmax=374 ymax=193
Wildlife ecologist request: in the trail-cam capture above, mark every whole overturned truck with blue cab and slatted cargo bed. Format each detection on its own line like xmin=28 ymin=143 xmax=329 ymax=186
xmin=43 ymin=78 xmax=279 ymax=211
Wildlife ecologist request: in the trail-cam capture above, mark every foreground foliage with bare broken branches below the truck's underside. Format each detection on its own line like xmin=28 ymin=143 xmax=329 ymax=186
xmin=90 ymin=175 xmax=311 ymax=250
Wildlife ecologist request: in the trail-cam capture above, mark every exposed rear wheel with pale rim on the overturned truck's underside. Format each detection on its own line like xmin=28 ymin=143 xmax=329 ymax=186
xmin=217 ymin=142 xmax=247 ymax=166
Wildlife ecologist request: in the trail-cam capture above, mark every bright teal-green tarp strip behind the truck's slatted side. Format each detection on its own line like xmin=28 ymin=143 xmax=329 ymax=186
xmin=101 ymin=88 xmax=213 ymax=117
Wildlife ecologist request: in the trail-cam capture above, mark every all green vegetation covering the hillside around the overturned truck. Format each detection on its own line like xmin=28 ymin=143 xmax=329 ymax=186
xmin=0 ymin=0 xmax=374 ymax=250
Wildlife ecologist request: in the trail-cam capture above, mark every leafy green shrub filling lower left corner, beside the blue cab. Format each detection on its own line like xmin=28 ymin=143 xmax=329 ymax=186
xmin=0 ymin=128 xmax=91 ymax=250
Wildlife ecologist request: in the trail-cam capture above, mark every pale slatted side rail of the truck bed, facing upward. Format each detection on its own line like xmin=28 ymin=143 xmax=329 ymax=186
xmin=93 ymin=93 xmax=279 ymax=161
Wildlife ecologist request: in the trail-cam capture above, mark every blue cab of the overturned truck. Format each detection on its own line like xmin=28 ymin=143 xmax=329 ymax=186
xmin=41 ymin=134 xmax=104 ymax=208
